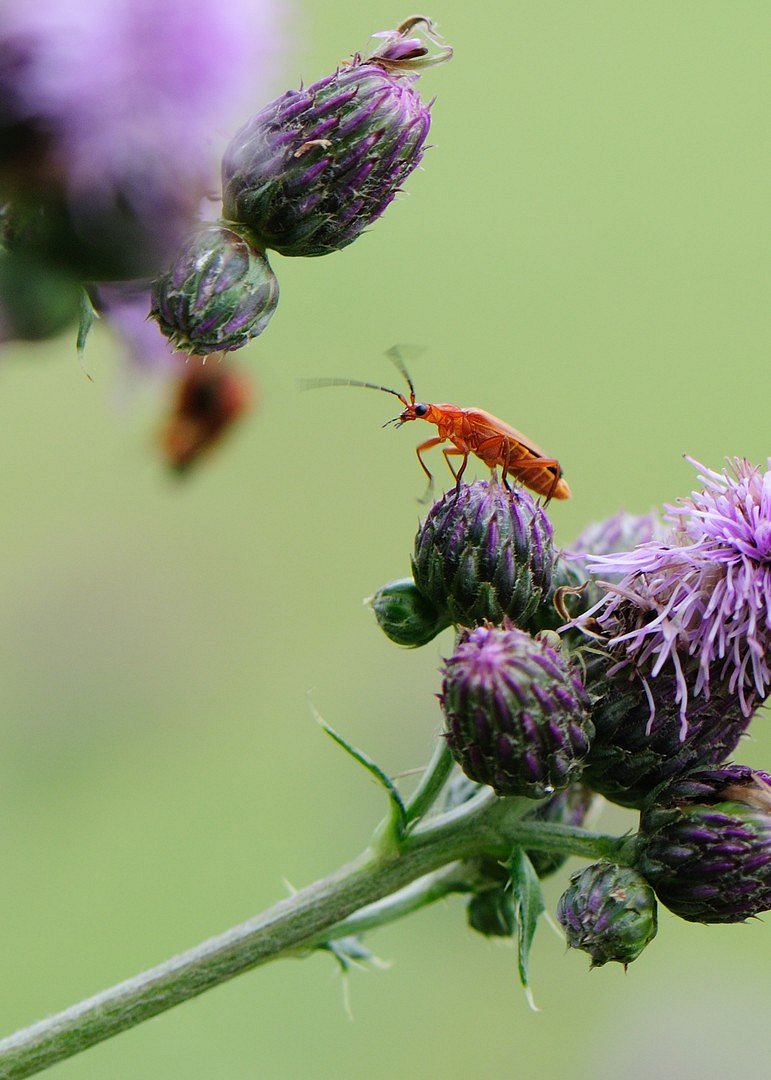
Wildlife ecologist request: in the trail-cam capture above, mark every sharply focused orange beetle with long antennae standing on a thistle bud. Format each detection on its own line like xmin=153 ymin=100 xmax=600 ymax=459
xmin=303 ymin=348 xmax=570 ymax=502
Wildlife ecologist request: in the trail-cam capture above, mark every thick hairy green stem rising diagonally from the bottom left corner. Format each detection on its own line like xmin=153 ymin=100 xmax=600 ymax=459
xmin=0 ymin=790 xmax=618 ymax=1080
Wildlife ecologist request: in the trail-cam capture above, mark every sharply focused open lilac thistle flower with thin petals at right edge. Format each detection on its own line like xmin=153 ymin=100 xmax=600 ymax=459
xmin=590 ymin=458 xmax=771 ymax=735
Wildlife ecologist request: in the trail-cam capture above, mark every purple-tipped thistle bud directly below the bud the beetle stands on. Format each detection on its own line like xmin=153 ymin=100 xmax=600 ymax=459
xmin=439 ymin=626 xmax=593 ymax=799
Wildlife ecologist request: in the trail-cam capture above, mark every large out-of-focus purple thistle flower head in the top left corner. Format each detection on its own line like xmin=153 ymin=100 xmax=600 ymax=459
xmin=0 ymin=0 xmax=278 ymax=279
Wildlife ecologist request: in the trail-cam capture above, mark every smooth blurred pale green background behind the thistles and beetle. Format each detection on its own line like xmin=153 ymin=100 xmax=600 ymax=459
xmin=0 ymin=0 xmax=771 ymax=1080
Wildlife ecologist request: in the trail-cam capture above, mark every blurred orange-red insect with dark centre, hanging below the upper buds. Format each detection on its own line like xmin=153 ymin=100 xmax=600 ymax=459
xmin=161 ymin=360 xmax=253 ymax=473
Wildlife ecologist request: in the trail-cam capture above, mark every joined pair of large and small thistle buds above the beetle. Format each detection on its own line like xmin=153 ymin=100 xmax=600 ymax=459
xmin=152 ymin=15 xmax=451 ymax=356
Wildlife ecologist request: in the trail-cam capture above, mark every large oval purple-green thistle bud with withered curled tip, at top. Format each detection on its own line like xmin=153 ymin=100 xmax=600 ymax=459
xmin=222 ymin=16 xmax=451 ymax=255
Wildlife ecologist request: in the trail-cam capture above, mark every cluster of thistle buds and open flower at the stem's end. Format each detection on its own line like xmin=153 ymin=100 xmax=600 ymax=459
xmin=370 ymin=459 xmax=771 ymax=966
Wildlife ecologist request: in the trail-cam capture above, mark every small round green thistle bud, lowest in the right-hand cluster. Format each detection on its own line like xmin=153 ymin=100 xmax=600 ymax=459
xmin=557 ymin=862 xmax=657 ymax=968
